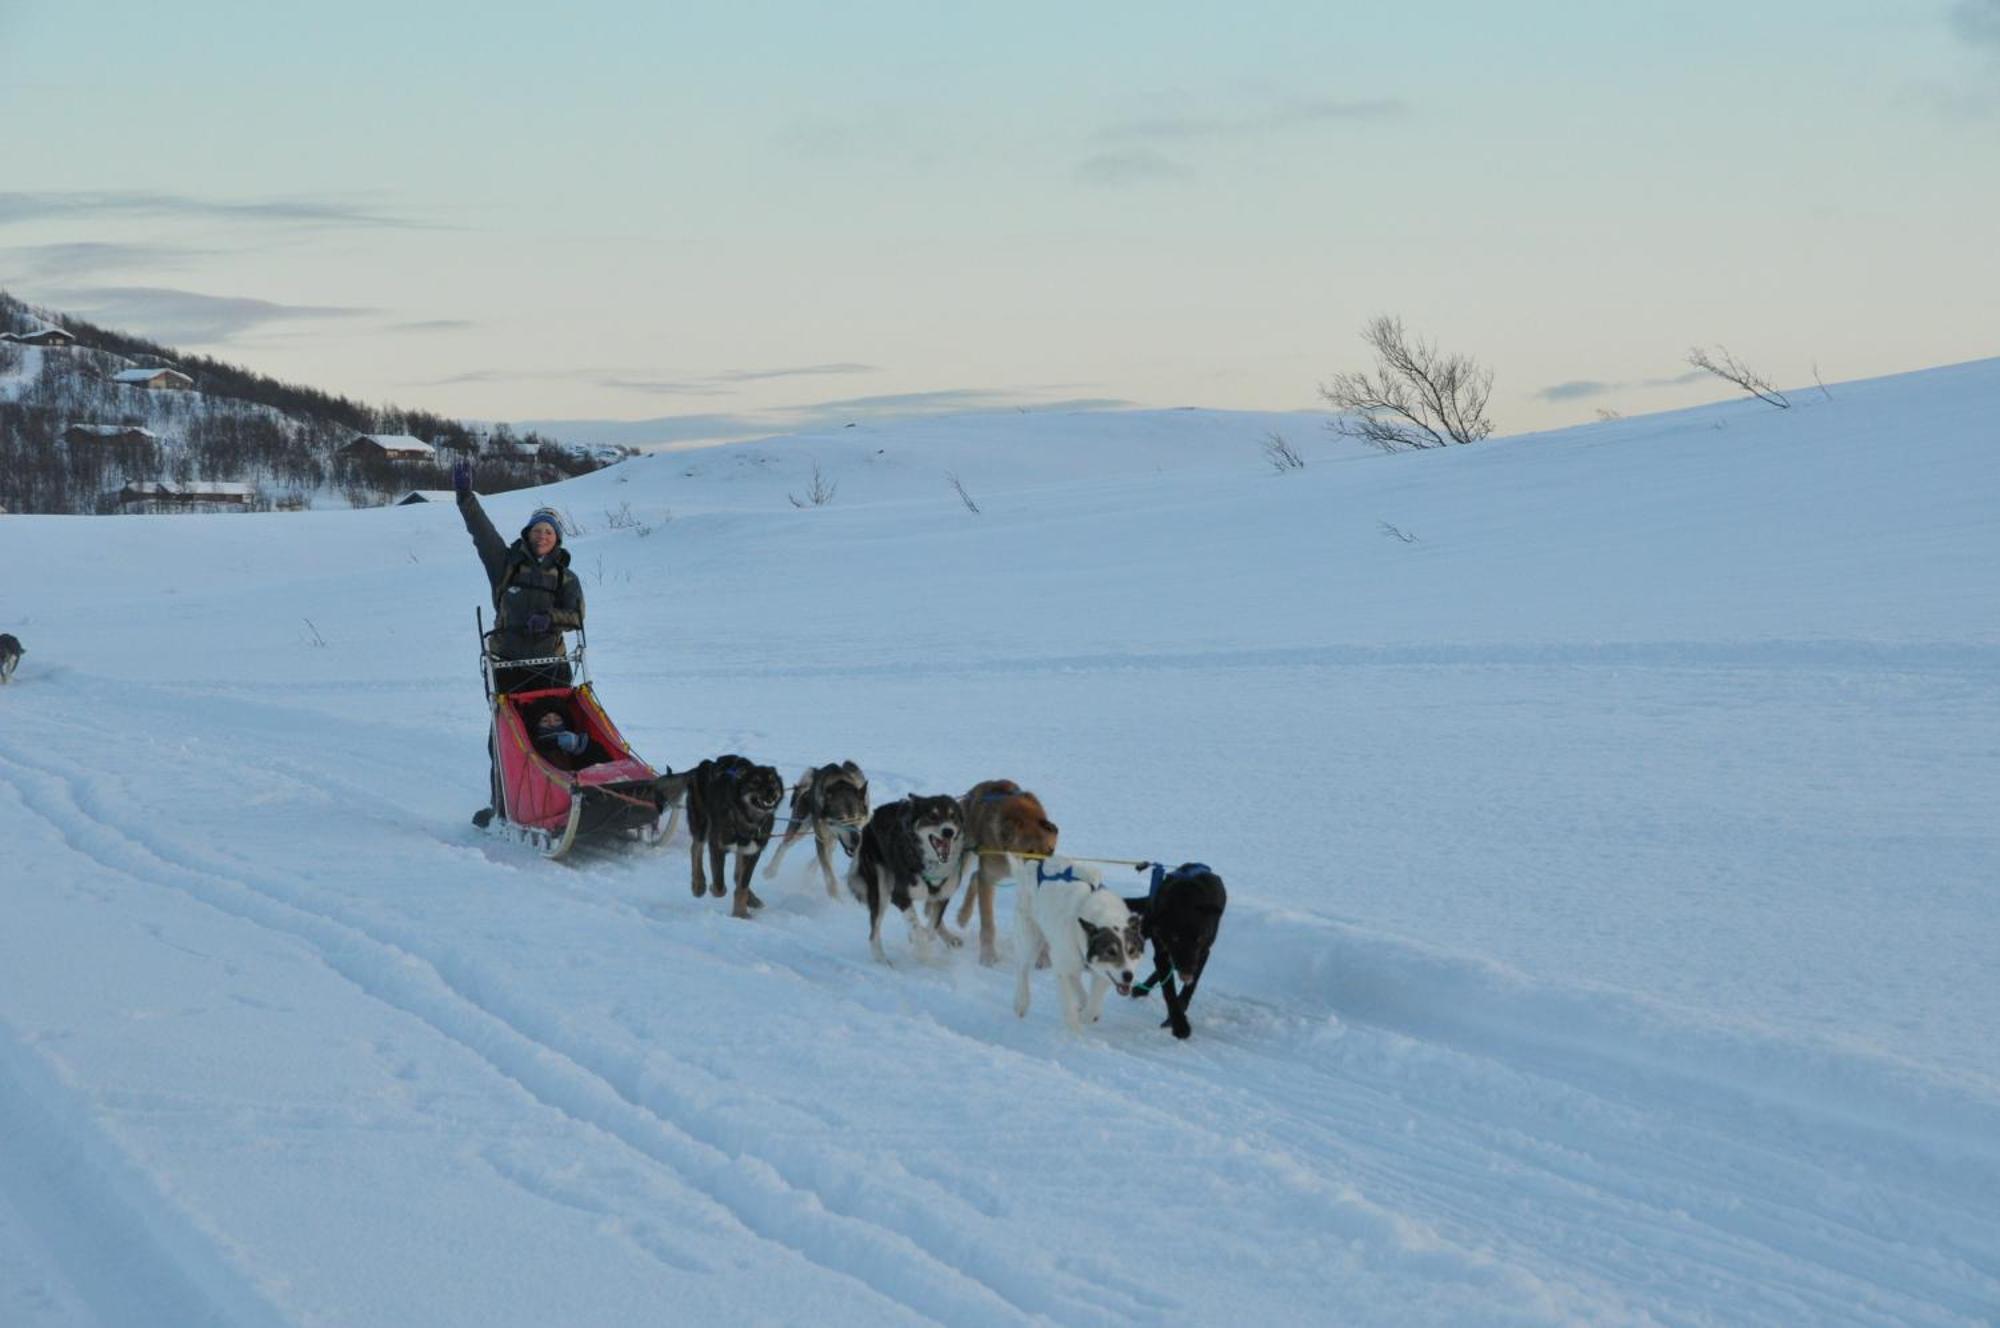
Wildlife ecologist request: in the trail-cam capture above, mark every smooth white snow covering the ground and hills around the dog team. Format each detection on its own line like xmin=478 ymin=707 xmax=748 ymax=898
xmin=0 ymin=360 xmax=2000 ymax=1328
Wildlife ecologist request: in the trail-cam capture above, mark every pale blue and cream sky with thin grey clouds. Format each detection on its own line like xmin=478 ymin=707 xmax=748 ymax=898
xmin=0 ymin=0 xmax=2000 ymax=440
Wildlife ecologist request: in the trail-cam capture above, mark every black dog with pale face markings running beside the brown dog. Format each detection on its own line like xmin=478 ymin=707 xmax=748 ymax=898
xmin=848 ymin=794 xmax=966 ymax=964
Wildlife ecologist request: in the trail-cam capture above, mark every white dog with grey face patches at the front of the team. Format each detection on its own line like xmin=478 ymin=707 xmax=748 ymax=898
xmin=1010 ymin=858 xmax=1146 ymax=1032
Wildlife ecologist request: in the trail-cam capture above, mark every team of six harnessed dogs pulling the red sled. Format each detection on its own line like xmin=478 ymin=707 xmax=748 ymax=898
xmin=660 ymin=754 xmax=1228 ymax=1038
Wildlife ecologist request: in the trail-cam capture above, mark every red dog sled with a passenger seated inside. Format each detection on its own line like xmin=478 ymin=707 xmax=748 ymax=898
xmin=480 ymin=616 xmax=670 ymax=858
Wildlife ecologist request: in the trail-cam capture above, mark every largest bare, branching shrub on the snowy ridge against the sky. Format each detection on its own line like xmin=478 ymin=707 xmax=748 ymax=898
xmin=1320 ymin=314 xmax=1494 ymax=452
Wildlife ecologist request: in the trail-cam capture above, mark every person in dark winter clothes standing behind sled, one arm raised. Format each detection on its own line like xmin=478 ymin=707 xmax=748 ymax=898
xmin=452 ymin=462 xmax=584 ymax=826
